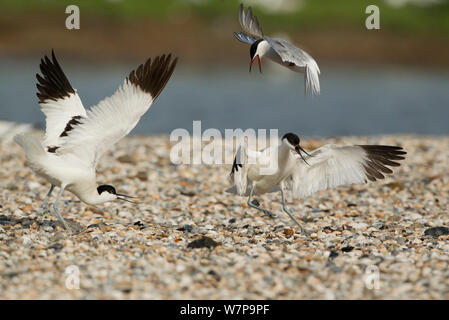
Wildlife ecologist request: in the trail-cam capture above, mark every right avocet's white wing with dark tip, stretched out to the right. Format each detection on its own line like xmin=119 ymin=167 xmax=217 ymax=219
xmin=291 ymin=145 xmax=406 ymax=198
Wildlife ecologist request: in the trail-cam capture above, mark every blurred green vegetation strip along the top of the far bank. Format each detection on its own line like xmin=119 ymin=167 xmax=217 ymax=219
xmin=0 ymin=0 xmax=449 ymax=36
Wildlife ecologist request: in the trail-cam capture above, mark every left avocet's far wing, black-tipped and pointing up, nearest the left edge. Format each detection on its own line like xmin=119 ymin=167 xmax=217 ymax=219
xmin=36 ymin=50 xmax=86 ymax=152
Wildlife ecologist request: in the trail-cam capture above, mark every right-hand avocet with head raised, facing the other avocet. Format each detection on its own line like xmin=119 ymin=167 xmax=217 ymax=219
xmin=226 ymin=133 xmax=406 ymax=234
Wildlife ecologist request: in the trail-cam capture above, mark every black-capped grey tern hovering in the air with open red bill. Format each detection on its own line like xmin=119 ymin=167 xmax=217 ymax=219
xmin=234 ymin=4 xmax=320 ymax=95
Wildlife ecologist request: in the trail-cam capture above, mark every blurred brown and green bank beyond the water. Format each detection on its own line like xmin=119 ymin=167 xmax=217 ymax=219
xmin=0 ymin=0 xmax=449 ymax=67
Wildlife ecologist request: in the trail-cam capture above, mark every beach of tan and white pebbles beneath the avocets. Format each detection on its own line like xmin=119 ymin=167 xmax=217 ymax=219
xmin=0 ymin=129 xmax=449 ymax=299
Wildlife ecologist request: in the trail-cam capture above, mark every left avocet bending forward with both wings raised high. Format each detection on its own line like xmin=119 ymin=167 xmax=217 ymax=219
xmin=14 ymin=51 xmax=177 ymax=231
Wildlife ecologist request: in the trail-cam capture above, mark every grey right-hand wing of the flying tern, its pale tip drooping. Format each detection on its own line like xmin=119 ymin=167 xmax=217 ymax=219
xmin=265 ymin=37 xmax=320 ymax=95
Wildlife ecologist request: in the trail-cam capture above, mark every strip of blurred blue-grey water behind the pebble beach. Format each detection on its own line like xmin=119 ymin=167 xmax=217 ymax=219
xmin=0 ymin=59 xmax=449 ymax=136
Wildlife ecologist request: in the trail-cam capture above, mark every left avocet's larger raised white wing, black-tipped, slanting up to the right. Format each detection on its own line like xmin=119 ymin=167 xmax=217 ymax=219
xmin=57 ymin=55 xmax=177 ymax=167
